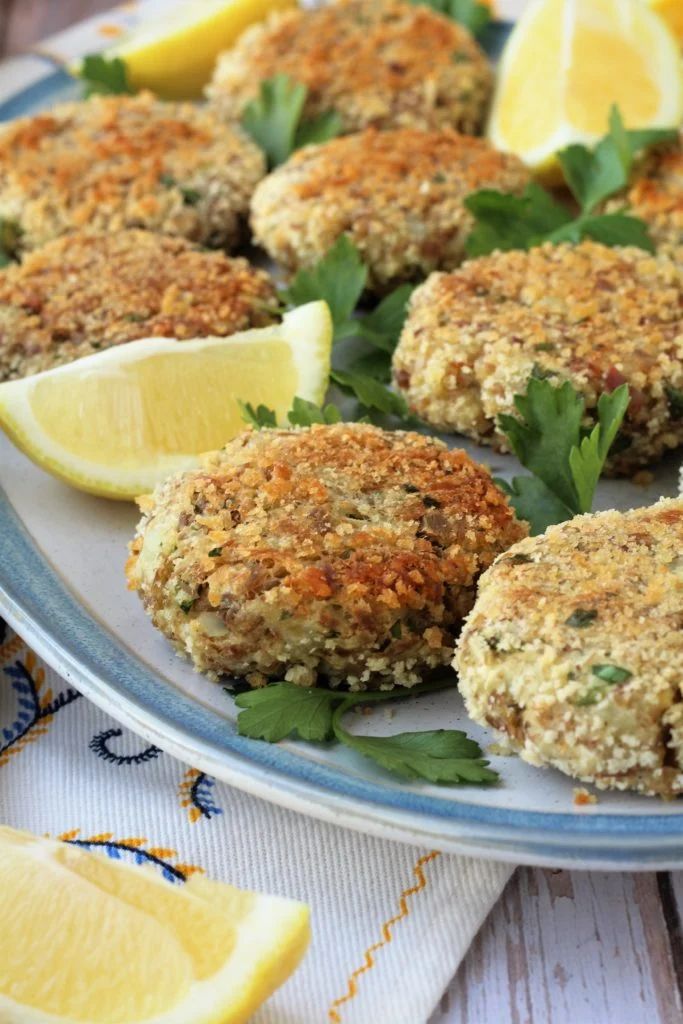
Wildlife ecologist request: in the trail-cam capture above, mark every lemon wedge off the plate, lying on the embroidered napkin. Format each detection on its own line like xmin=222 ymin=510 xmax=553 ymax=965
xmin=0 ymin=827 xmax=309 ymax=1024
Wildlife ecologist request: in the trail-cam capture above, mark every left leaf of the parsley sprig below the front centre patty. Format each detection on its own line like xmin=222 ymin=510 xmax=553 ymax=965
xmin=234 ymin=683 xmax=339 ymax=743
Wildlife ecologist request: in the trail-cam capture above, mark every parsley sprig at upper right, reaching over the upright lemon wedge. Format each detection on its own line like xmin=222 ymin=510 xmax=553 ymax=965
xmin=465 ymin=106 xmax=678 ymax=256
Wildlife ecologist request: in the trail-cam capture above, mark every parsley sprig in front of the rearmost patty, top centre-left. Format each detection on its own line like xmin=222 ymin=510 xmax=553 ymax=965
xmin=242 ymin=74 xmax=342 ymax=167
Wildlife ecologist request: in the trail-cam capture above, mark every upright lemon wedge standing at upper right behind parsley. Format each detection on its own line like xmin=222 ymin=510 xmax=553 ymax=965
xmin=488 ymin=0 xmax=683 ymax=174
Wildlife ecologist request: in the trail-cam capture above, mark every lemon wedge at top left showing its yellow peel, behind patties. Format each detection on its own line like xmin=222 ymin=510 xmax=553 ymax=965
xmin=100 ymin=0 xmax=296 ymax=99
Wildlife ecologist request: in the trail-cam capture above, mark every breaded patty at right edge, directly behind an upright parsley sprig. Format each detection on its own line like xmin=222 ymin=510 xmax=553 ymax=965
xmin=393 ymin=242 xmax=683 ymax=473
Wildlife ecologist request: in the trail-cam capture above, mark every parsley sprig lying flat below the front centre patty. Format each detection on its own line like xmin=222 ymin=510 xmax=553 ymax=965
xmin=236 ymin=680 xmax=499 ymax=784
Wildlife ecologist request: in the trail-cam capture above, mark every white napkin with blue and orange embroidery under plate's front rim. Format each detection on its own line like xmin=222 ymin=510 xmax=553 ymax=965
xmin=0 ymin=626 xmax=512 ymax=1024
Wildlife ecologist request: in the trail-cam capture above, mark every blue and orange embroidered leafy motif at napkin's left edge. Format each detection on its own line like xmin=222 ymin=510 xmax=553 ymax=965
xmin=0 ymin=655 xmax=81 ymax=766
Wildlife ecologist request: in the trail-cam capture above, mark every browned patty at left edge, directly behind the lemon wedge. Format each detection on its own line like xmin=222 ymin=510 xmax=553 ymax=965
xmin=0 ymin=230 xmax=276 ymax=380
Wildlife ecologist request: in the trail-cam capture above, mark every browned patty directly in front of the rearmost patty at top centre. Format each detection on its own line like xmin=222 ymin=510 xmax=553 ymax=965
xmin=252 ymin=128 xmax=528 ymax=291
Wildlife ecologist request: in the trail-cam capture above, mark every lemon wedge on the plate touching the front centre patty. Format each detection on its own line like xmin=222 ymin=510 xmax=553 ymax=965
xmin=0 ymin=302 xmax=332 ymax=500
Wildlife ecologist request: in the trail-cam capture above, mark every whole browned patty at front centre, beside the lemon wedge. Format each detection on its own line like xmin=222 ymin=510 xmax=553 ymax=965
xmin=127 ymin=423 xmax=526 ymax=689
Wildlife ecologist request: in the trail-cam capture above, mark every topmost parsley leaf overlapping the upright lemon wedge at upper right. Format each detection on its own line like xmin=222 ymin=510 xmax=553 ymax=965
xmin=557 ymin=105 xmax=678 ymax=214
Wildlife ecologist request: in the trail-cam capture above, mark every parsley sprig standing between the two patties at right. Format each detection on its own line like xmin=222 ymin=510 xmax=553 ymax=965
xmin=498 ymin=377 xmax=629 ymax=535
